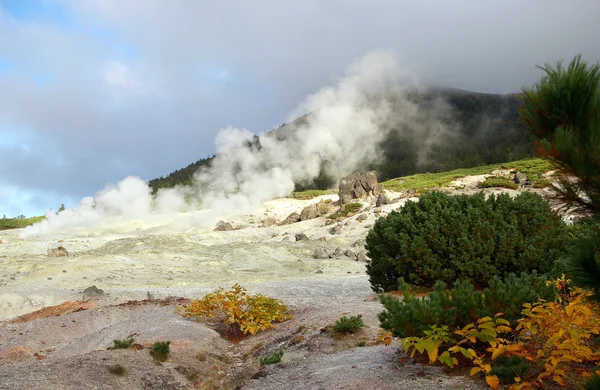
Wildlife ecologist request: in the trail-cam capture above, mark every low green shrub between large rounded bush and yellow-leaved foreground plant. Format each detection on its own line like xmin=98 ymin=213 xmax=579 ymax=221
xmin=379 ymin=274 xmax=556 ymax=337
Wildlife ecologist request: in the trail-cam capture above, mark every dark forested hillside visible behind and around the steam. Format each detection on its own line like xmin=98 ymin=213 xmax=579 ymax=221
xmin=149 ymin=87 xmax=535 ymax=192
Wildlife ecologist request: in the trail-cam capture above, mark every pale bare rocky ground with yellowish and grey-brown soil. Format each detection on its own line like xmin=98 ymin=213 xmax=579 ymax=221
xmin=0 ymin=184 xmax=544 ymax=389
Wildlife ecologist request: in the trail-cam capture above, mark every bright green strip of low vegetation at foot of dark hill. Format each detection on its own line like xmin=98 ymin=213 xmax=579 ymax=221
xmin=382 ymin=158 xmax=553 ymax=192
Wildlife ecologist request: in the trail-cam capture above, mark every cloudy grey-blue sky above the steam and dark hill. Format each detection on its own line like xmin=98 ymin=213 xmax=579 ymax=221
xmin=0 ymin=0 xmax=600 ymax=217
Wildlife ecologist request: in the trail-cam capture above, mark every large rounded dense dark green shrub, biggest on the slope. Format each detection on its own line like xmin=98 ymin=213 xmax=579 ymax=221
xmin=366 ymin=191 xmax=568 ymax=292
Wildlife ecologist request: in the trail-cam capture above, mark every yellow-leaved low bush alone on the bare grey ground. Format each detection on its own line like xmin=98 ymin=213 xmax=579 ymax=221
xmin=176 ymin=284 xmax=291 ymax=339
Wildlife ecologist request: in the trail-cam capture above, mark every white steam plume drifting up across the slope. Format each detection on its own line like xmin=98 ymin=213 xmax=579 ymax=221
xmin=22 ymin=51 xmax=452 ymax=236
